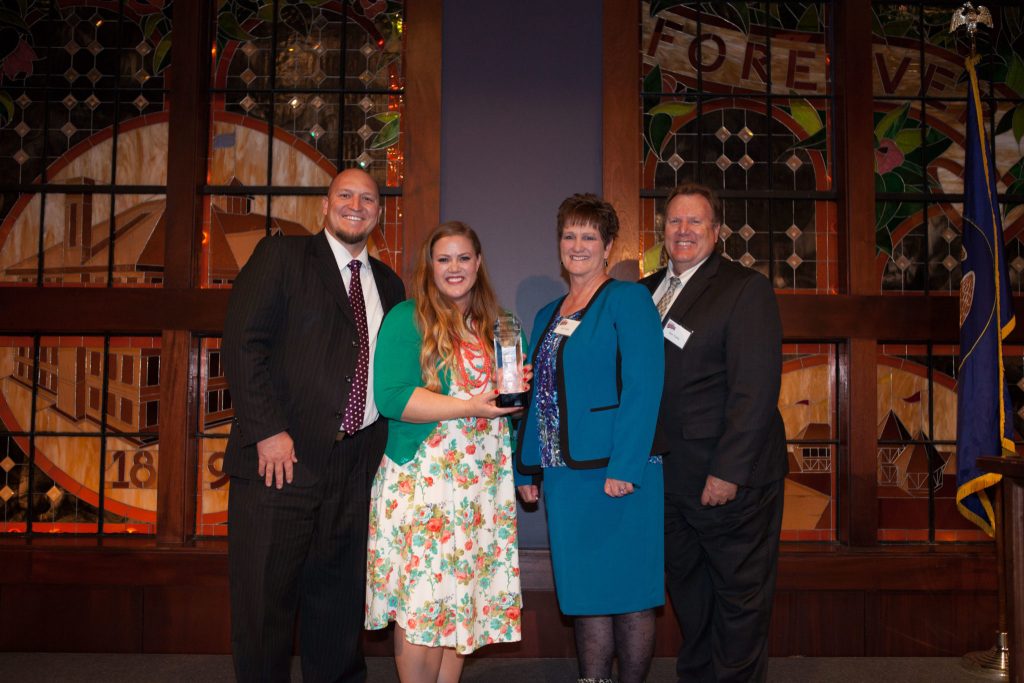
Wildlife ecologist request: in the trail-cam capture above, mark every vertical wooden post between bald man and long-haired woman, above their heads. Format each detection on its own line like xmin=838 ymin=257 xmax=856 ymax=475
xmin=398 ymin=0 xmax=443 ymax=283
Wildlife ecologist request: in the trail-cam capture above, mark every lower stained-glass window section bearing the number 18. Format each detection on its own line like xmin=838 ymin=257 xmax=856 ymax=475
xmin=0 ymin=335 xmax=161 ymax=535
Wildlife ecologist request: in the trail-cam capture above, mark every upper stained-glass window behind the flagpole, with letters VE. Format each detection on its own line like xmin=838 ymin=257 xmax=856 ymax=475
xmin=871 ymin=2 xmax=1024 ymax=294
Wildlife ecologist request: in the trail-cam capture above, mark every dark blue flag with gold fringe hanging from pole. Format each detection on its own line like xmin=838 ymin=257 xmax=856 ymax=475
xmin=956 ymin=57 xmax=1014 ymax=536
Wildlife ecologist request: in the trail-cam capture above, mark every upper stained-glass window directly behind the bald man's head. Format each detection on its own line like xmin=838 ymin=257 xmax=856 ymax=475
xmin=201 ymin=0 xmax=404 ymax=287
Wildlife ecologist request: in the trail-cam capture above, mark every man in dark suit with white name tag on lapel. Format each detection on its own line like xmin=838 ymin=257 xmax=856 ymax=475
xmin=643 ymin=183 xmax=787 ymax=681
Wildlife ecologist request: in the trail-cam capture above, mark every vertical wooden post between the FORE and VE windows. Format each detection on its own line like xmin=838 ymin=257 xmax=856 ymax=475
xmin=831 ymin=0 xmax=880 ymax=546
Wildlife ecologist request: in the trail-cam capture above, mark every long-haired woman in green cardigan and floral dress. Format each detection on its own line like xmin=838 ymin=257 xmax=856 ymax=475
xmin=366 ymin=222 xmax=528 ymax=683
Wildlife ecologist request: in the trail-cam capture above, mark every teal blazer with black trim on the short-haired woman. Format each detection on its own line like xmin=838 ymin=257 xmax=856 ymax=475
xmin=515 ymin=280 xmax=665 ymax=485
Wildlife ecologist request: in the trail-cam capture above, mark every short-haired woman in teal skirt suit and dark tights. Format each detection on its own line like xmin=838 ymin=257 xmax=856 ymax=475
xmin=516 ymin=195 xmax=665 ymax=683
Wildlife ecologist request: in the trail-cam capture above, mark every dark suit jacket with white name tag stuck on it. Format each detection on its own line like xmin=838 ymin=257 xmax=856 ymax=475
xmin=641 ymin=253 xmax=788 ymax=492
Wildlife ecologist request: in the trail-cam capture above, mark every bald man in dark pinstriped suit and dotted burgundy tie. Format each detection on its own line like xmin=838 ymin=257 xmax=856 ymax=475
xmin=222 ymin=169 xmax=404 ymax=682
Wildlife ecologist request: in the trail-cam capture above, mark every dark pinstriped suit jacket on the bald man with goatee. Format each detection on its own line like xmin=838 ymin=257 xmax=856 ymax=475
xmin=221 ymin=231 xmax=406 ymax=486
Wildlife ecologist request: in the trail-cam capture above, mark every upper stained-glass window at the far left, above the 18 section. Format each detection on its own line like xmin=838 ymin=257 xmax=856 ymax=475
xmin=0 ymin=0 xmax=173 ymax=287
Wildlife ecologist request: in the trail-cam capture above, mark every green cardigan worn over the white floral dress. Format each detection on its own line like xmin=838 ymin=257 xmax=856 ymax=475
xmin=374 ymin=299 xmax=450 ymax=465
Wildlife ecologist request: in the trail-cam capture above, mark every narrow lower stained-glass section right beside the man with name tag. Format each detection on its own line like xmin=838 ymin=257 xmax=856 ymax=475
xmin=778 ymin=344 xmax=839 ymax=541
